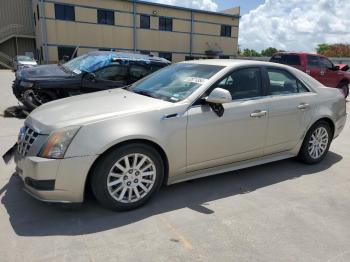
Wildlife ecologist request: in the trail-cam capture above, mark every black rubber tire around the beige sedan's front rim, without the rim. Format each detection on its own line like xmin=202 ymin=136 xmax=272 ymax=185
xmin=91 ymin=143 xmax=164 ymax=211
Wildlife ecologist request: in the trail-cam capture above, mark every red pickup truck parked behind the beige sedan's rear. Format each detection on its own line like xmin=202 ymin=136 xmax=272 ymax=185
xmin=270 ymin=52 xmax=350 ymax=97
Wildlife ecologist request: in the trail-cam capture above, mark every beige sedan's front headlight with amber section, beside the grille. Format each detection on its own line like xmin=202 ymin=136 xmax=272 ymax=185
xmin=39 ymin=126 xmax=80 ymax=159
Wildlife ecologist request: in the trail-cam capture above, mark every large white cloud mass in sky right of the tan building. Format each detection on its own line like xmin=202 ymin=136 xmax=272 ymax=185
xmin=239 ymin=0 xmax=350 ymax=51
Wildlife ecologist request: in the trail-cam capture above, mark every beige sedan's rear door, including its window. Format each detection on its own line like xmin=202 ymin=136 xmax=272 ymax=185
xmin=264 ymin=68 xmax=316 ymax=155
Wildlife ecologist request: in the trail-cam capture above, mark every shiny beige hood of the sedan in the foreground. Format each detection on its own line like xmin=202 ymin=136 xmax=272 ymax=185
xmin=26 ymin=89 xmax=174 ymax=134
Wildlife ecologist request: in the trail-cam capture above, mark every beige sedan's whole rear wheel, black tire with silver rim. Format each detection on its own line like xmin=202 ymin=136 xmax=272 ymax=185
xmin=298 ymin=121 xmax=333 ymax=165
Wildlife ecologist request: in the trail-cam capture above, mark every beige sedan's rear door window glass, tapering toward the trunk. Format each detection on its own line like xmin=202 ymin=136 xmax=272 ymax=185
xmin=267 ymin=68 xmax=308 ymax=95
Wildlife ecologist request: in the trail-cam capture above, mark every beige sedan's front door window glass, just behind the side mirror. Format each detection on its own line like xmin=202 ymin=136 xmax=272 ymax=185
xmin=216 ymin=68 xmax=262 ymax=100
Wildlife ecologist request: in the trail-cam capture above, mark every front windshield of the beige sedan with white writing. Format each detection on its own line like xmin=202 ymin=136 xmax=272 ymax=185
xmin=128 ymin=63 xmax=224 ymax=103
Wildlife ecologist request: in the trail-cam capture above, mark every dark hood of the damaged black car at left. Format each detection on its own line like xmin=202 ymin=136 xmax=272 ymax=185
xmin=17 ymin=65 xmax=70 ymax=80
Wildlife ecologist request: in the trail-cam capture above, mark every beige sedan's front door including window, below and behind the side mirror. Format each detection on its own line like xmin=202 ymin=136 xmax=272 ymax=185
xmin=187 ymin=68 xmax=268 ymax=172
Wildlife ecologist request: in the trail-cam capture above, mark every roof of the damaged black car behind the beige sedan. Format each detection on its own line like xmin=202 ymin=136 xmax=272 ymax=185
xmin=89 ymin=51 xmax=171 ymax=64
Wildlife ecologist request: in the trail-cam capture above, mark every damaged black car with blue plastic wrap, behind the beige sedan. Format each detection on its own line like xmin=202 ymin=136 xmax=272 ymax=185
xmin=12 ymin=51 xmax=171 ymax=111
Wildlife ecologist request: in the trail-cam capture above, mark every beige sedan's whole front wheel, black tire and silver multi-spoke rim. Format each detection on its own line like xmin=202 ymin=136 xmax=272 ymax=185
xmin=91 ymin=143 xmax=164 ymax=211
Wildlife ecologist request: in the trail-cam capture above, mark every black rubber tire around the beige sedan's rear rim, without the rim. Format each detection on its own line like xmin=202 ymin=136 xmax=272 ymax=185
xmin=297 ymin=121 xmax=333 ymax=165
